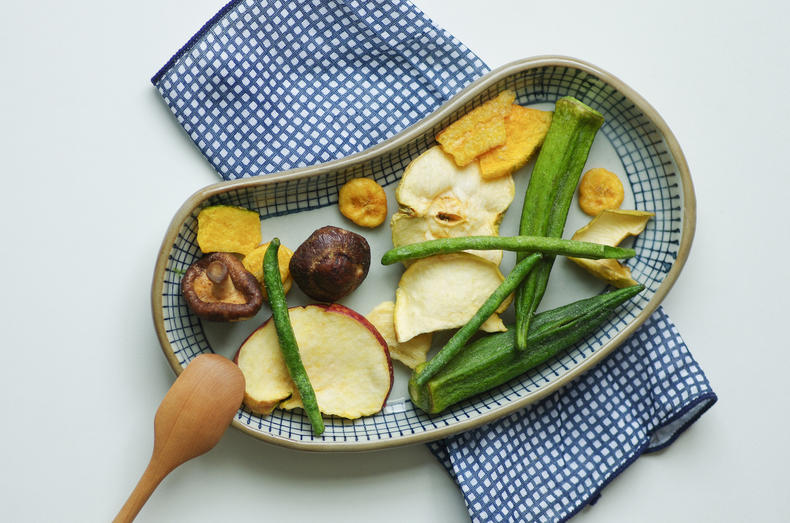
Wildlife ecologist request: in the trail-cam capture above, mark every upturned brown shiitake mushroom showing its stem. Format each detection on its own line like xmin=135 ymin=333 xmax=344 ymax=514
xmin=181 ymin=252 xmax=263 ymax=321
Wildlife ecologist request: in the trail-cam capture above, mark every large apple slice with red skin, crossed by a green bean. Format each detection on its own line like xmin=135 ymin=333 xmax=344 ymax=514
xmin=234 ymin=303 xmax=393 ymax=419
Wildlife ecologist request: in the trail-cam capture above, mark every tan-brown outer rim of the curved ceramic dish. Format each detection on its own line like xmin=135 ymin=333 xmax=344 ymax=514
xmin=151 ymin=55 xmax=697 ymax=452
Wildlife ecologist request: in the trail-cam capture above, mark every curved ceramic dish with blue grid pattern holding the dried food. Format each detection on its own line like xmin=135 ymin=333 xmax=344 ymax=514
xmin=152 ymin=57 xmax=695 ymax=451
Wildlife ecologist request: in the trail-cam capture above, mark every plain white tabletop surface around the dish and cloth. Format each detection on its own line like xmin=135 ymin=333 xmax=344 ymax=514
xmin=0 ymin=0 xmax=790 ymax=523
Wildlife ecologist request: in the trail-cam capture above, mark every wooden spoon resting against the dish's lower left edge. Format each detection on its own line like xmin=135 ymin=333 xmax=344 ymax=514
xmin=113 ymin=354 xmax=244 ymax=523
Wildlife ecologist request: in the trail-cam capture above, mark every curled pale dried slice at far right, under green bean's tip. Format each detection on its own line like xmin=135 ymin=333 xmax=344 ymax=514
xmin=569 ymin=209 xmax=655 ymax=288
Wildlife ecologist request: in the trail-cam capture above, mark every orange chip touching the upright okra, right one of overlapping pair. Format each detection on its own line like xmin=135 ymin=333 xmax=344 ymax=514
xmin=480 ymin=105 xmax=552 ymax=180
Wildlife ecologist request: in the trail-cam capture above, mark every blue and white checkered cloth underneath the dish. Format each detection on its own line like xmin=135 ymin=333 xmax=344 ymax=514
xmin=152 ymin=0 xmax=716 ymax=521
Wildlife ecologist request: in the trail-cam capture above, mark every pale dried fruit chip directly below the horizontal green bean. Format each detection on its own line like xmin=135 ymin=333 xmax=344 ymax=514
xmin=394 ymin=252 xmax=512 ymax=343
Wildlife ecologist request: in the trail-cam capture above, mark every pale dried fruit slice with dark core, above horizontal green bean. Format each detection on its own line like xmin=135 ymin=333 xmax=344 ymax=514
xmin=390 ymin=146 xmax=515 ymax=265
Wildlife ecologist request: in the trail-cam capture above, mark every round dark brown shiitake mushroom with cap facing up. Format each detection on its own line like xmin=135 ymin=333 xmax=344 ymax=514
xmin=289 ymin=225 xmax=370 ymax=302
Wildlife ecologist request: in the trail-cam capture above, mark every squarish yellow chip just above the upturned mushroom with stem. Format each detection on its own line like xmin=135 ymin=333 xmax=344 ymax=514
xmin=197 ymin=205 xmax=261 ymax=255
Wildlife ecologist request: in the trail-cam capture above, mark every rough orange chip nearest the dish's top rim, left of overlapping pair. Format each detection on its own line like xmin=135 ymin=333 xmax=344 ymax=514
xmin=436 ymin=90 xmax=516 ymax=167
